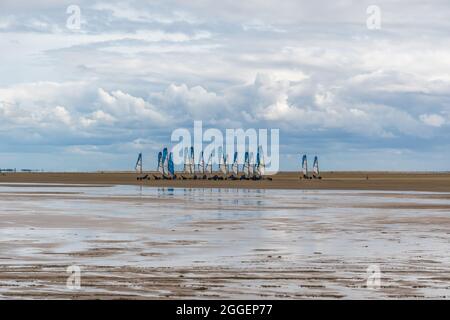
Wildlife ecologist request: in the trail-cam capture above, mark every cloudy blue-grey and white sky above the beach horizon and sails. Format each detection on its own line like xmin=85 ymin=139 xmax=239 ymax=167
xmin=0 ymin=0 xmax=450 ymax=170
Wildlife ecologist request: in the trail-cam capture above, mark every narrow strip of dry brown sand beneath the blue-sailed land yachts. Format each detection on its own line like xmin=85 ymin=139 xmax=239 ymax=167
xmin=0 ymin=172 xmax=450 ymax=192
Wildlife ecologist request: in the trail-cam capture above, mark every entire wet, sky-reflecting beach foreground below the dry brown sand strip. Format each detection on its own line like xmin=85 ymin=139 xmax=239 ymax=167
xmin=0 ymin=183 xmax=450 ymax=299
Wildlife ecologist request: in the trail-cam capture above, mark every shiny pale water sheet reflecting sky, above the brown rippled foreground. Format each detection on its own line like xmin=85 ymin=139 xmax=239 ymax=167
xmin=0 ymin=185 xmax=450 ymax=266
